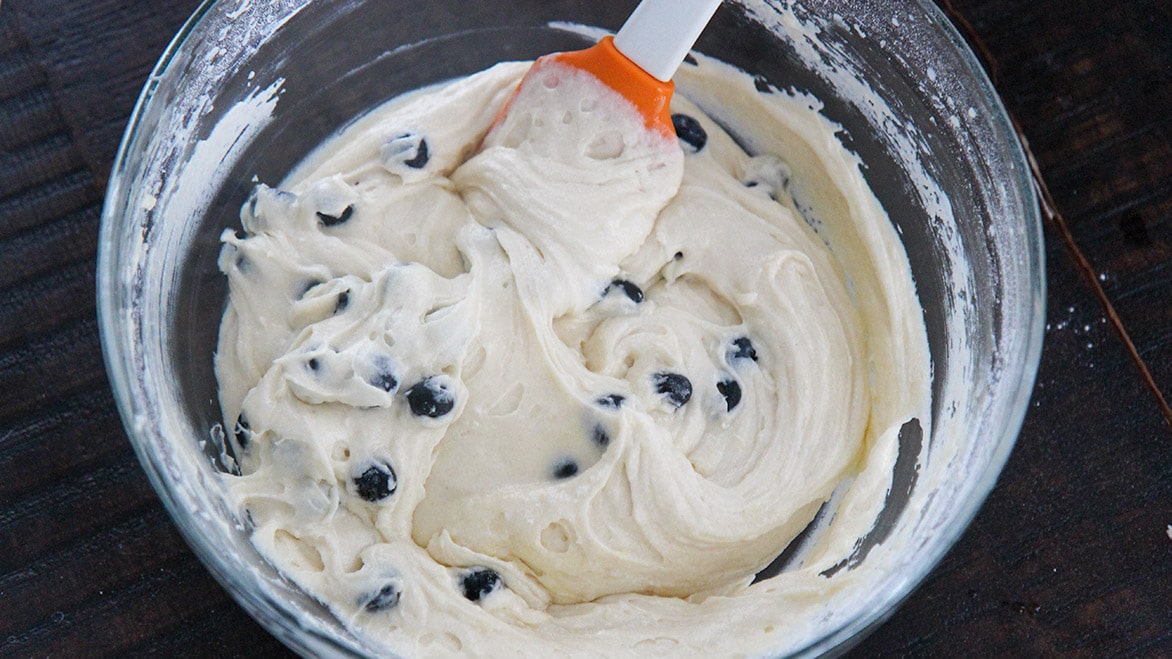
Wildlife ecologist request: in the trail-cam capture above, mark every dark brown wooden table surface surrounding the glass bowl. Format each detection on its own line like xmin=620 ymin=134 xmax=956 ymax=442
xmin=0 ymin=0 xmax=1172 ymax=657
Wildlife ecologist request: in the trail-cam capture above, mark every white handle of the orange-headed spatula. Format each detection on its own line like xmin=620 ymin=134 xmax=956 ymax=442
xmin=614 ymin=0 xmax=721 ymax=82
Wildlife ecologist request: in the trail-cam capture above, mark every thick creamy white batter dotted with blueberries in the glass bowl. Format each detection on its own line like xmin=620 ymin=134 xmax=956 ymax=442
xmin=216 ymin=52 xmax=928 ymax=657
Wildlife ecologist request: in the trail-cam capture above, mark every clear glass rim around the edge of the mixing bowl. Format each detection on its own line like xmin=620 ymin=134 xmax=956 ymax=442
xmin=96 ymin=0 xmax=1047 ymax=655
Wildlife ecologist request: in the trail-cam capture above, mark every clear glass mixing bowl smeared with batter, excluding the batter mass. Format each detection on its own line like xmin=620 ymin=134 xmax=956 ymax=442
xmin=98 ymin=0 xmax=1044 ymax=655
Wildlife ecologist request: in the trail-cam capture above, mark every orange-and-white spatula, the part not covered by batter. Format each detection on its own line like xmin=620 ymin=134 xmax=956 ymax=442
xmin=487 ymin=0 xmax=721 ymax=137
